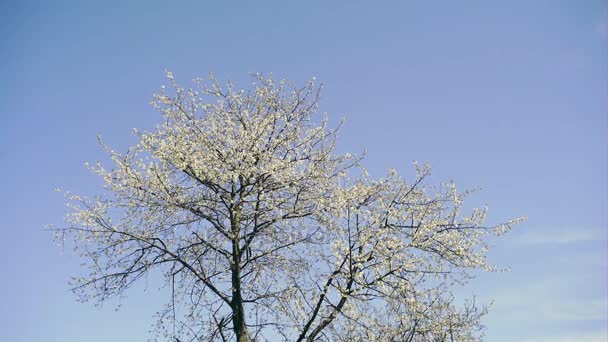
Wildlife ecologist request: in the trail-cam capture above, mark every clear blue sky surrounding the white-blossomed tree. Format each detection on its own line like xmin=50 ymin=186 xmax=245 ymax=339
xmin=0 ymin=0 xmax=608 ymax=342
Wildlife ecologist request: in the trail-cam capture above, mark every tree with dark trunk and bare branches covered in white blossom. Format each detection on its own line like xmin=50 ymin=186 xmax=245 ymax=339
xmin=57 ymin=73 xmax=515 ymax=341
